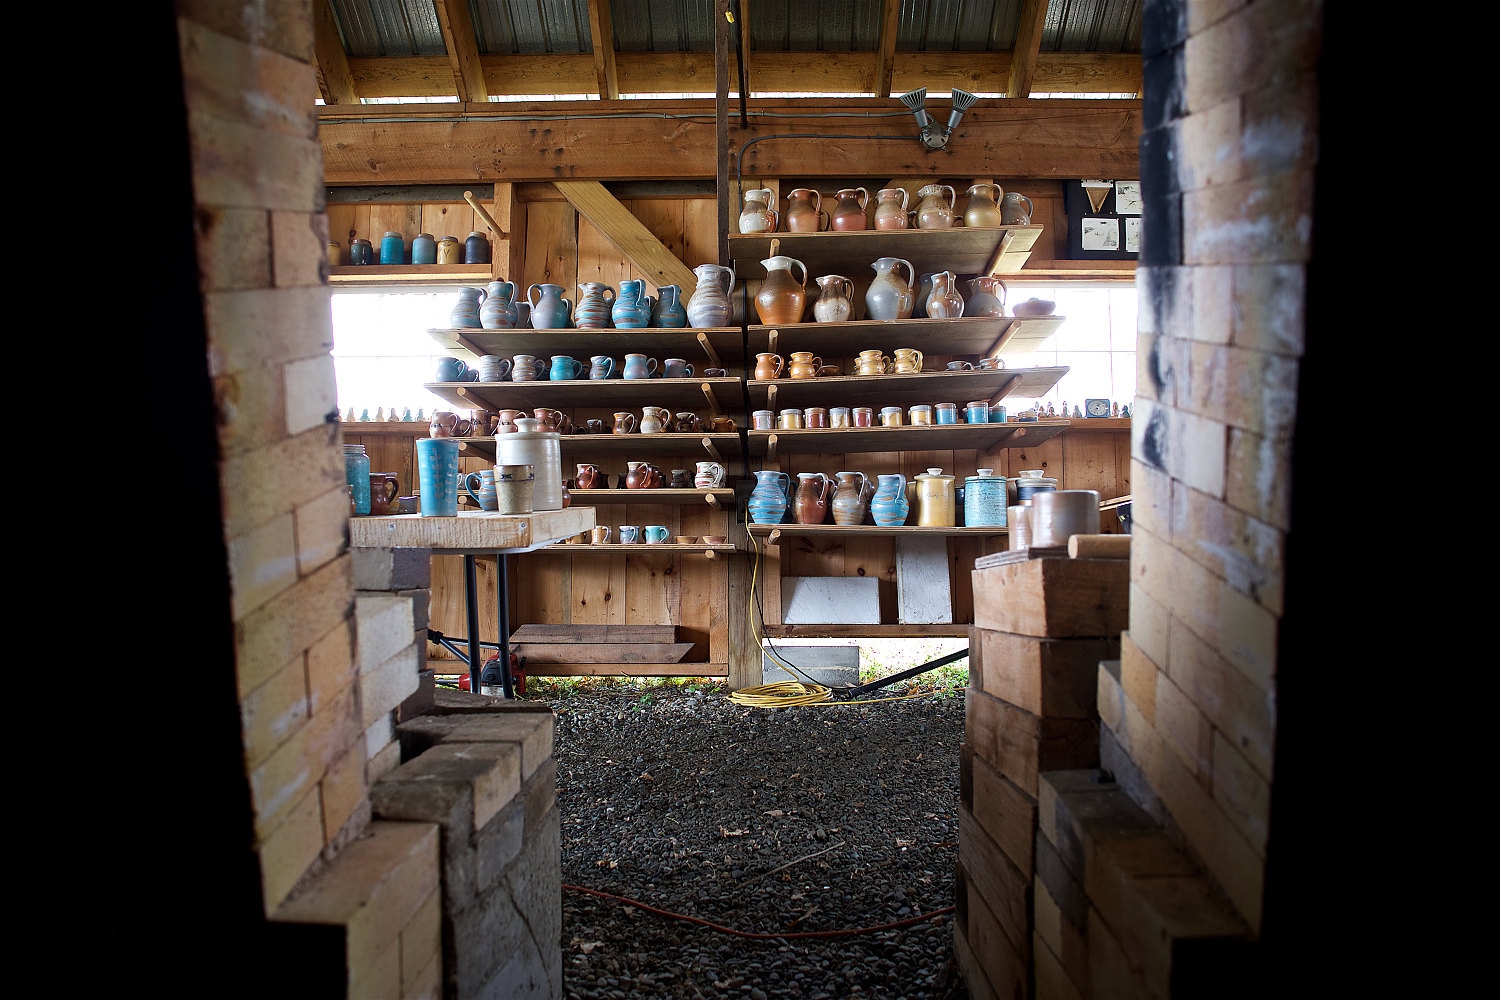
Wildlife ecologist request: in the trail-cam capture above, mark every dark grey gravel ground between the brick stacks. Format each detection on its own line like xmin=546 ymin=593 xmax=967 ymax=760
xmin=552 ymin=687 xmax=968 ymax=1000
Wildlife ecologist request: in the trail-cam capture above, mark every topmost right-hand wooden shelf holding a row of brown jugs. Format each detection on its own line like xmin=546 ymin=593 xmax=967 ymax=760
xmin=729 ymin=223 xmax=1043 ymax=275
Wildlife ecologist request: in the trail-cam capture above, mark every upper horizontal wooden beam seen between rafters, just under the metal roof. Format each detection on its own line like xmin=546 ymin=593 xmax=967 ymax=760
xmin=337 ymin=51 xmax=1142 ymax=103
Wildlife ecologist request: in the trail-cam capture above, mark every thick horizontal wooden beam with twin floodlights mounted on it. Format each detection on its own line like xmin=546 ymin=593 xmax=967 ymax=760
xmin=318 ymin=97 xmax=1143 ymax=186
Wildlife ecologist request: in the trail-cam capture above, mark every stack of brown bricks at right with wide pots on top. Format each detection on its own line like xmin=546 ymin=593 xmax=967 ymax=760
xmin=954 ymin=553 xmax=1130 ymax=1000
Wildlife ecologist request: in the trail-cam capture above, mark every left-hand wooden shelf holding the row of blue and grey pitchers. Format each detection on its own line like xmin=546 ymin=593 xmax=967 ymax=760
xmin=428 ymin=327 xmax=746 ymax=369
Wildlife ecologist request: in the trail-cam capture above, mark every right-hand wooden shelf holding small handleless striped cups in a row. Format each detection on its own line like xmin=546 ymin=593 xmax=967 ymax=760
xmin=747 ymin=420 xmax=1074 ymax=462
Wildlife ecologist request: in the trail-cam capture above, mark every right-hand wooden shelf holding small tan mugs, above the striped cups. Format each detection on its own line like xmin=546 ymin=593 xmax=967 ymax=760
xmin=746 ymin=364 xmax=1068 ymax=412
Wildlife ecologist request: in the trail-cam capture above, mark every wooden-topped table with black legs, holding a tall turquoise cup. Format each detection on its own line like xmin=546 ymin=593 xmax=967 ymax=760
xmin=350 ymin=507 xmax=594 ymax=697
